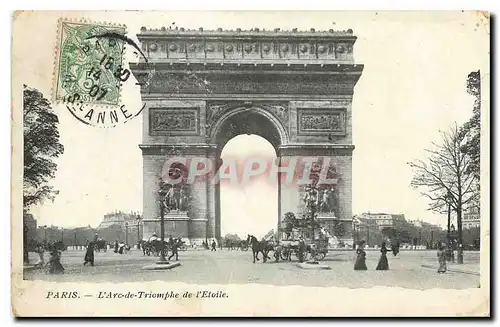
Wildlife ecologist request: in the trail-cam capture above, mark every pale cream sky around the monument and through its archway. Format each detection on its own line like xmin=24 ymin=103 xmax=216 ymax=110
xmin=14 ymin=12 xmax=489 ymax=234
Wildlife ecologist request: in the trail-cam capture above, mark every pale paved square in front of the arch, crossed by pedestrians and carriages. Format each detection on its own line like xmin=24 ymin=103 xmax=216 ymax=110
xmin=25 ymin=250 xmax=479 ymax=289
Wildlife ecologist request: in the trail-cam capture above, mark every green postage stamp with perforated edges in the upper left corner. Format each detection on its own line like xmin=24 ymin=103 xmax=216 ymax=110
xmin=54 ymin=21 xmax=130 ymax=107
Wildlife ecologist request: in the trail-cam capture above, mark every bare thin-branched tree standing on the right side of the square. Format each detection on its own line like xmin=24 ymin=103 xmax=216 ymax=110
xmin=409 ymin=125 xmax=479 ymax=263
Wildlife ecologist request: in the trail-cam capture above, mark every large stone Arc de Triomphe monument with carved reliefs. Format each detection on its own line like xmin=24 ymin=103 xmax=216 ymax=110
xmin=131 ymin=28 xmax=363 ymax=243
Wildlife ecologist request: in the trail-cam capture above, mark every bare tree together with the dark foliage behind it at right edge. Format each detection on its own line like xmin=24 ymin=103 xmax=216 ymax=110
xmin=409 ymin=71 xmax=481 ymax=263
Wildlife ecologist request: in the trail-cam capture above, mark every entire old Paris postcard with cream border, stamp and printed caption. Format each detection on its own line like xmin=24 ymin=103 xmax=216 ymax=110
xmin=11 ymin=11 xmax=491 ymax=317
